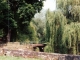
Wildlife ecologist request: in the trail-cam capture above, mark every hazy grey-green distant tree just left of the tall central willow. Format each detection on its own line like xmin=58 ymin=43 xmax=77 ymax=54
xmin=32 ymin=18 xmax=46 ymax=43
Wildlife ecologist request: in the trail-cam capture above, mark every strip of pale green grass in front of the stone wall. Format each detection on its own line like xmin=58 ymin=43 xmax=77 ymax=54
xmin=0 ymin=56 xmax=42 ymax=60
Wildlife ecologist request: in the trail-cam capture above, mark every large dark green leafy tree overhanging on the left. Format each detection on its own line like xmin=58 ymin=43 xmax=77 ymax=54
xmin=0 ymin=0 xmax=44 ymax=41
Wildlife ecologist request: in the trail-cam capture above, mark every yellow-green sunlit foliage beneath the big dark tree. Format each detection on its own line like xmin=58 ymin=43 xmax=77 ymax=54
xmin=18 ymin=22 xmax=38 ymax=43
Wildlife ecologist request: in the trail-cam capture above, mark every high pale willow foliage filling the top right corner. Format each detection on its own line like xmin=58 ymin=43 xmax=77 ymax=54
xmin=56 ymin=0 xmax=80 ymax=23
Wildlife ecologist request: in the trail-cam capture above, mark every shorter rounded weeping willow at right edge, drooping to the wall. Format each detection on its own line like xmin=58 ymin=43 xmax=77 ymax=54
xmin=62 ymin=23 xmax=80 ymax=54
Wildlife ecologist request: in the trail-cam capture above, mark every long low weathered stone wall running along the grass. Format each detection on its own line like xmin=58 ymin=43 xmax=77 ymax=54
xmin=0 ymin=48 xmax=80 ymax=60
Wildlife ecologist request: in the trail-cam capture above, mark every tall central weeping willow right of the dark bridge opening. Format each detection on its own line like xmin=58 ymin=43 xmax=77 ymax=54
xmin=46 ymin=10 xmax=67 ymax=53
